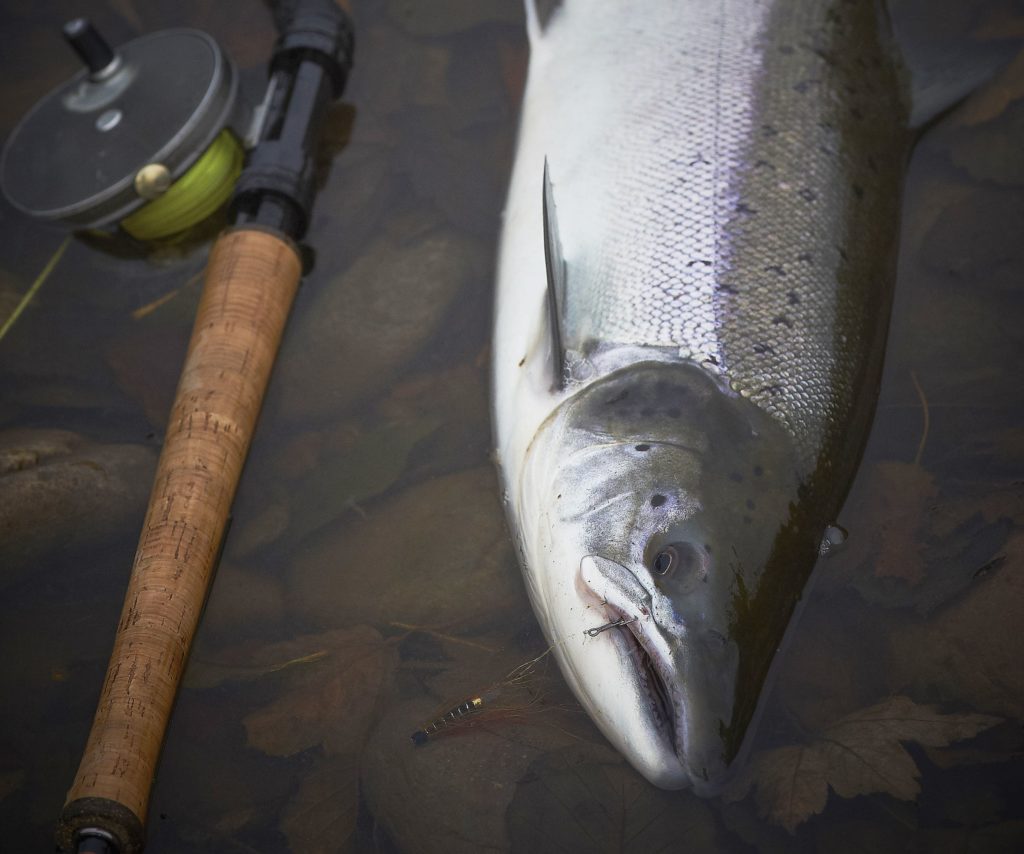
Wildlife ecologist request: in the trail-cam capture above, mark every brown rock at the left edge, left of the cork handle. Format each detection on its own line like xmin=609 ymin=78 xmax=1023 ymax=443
xmin=0 ymin=430 xmax=157 ymax=584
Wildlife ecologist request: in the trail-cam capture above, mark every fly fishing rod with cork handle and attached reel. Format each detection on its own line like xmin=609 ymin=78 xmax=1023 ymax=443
xmin=0 ymin=0 xmax=353 ymax=854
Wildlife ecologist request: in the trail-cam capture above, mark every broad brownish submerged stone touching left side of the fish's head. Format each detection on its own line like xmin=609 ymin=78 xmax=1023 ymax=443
xmin=289 ymin=466 xmax=528 ymax=630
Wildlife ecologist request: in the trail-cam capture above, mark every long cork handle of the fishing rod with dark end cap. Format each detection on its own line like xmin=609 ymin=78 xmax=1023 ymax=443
xmin=57 ymin=229 xmax=301 ymax=854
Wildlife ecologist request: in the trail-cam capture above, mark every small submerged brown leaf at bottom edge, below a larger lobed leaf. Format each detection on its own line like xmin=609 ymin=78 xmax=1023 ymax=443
xmin=281 ymin=754 xmax=359 ymax=854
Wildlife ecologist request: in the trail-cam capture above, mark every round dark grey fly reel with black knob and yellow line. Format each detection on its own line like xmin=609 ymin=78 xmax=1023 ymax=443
xmin=0 ymin=18 xmax=249 ymax=241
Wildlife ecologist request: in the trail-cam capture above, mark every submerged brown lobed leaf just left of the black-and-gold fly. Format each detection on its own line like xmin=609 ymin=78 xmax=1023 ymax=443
xmin=243 ymin=626 xmax=396 ymax=756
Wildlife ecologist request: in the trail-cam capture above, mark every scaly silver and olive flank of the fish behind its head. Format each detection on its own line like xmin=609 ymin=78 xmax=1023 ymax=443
xmin=540 ymin=0 xmax=903 ymax=466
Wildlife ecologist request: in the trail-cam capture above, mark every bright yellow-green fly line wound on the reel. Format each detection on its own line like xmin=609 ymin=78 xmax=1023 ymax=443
xmin=121 ymin=130 xmax=244 ymax=241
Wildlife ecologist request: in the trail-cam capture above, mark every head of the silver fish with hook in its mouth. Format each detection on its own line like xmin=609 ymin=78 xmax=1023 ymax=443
xmin=527 ymin=356 xmax=799 ymax=794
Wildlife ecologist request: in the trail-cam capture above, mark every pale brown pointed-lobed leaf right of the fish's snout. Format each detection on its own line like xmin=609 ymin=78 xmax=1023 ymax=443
xmin=725 ymin=696 xmax=999 ymax=832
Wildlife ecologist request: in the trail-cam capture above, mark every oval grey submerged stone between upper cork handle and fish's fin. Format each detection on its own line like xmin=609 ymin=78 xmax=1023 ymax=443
xmin=272 ymin=217 xmax=488 ymax=421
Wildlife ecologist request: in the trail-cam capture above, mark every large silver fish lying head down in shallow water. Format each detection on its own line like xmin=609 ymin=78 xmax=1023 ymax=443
xmin=494 ymin=0 xmax=906 ymax=792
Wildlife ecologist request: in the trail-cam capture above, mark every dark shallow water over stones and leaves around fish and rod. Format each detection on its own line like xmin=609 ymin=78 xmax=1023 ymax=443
xmin=0 ymin=0 xmax=1024 ymax=852
